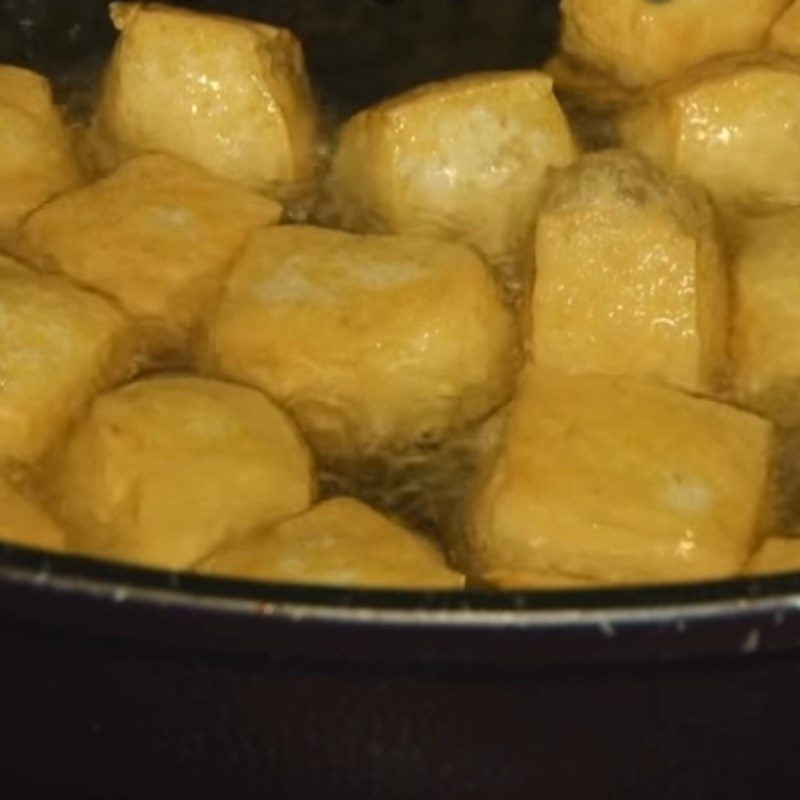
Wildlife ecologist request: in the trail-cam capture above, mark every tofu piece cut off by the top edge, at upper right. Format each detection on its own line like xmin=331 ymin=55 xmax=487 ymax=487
xmin=561 ymin=0 xmax=789 ymax=87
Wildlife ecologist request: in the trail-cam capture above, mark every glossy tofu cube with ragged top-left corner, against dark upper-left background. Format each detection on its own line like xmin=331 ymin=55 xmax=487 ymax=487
xmin=96 ymin=3 xmax=317 ymax=194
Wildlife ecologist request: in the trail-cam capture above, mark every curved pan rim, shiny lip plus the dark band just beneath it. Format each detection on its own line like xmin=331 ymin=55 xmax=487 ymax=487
xmin=0 ymin=545 xmax=800 ymax=672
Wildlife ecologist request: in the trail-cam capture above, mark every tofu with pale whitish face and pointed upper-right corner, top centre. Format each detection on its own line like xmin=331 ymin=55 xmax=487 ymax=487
xmin=329 ymin=71 xmax=577 ymax=290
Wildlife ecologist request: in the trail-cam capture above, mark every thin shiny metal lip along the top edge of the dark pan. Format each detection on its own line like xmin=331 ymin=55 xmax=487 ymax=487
xmin=0 ymin=542 xmax=800 ymax=625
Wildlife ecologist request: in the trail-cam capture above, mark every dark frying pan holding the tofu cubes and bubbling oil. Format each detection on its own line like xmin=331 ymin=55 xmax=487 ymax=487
xmin=0 ymin=0 xmax=800 ymax=800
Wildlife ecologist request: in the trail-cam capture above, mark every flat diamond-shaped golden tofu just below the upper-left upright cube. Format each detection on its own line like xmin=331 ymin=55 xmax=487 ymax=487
xmin=19 ymin=155 xmax=281 ymax=354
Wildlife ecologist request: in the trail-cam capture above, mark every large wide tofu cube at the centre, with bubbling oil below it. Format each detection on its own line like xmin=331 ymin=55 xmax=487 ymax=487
xmin=201 ymin=226 xmax=516 ymax=456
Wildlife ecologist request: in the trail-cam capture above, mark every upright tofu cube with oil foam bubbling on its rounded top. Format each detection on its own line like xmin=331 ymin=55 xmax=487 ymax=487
xmin=526 ymin=150 xmax=728 ymax=392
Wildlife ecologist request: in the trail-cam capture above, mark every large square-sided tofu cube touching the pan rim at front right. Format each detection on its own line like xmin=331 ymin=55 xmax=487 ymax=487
xmin=468 ymin=368 xmax=773 ymax=583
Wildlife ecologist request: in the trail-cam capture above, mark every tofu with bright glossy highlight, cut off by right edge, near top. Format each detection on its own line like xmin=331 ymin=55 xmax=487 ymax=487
xmin=619 ymin=53 xmax=800 ymax=212
